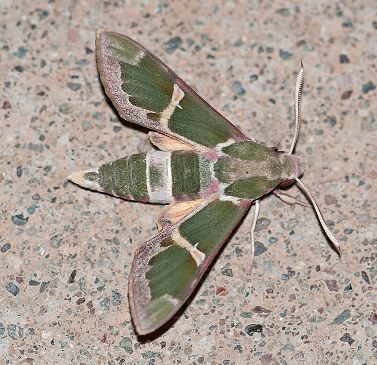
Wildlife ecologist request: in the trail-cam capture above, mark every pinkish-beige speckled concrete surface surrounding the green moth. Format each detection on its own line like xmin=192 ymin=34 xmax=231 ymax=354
xmin=0 ymin=0 xmax=377 ymax=365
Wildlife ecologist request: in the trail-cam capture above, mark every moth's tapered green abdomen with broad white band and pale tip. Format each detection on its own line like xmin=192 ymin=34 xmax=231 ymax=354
xmin=68 ymin=151 xmax=217 ymax=204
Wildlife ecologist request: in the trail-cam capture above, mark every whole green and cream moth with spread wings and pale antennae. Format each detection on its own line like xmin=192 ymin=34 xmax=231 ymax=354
xmin=68 ymin=30 xmax=340 ymax=335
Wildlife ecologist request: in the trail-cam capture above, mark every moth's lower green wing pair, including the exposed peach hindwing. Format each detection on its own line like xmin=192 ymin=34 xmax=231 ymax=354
xmin=129 ymin=197 xmax=250 ymax=335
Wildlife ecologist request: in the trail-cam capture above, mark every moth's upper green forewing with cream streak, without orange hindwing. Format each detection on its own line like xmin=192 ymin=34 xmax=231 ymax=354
xmin=96 ymin=30 xmax=247 ymax=151
